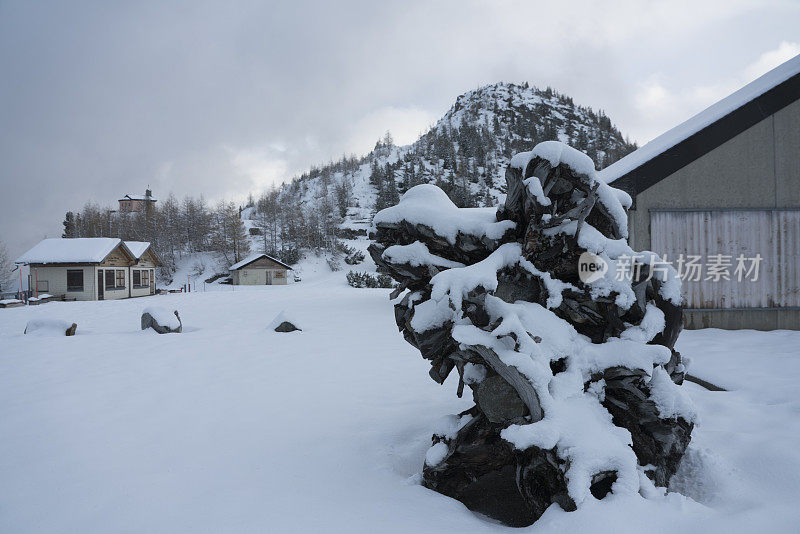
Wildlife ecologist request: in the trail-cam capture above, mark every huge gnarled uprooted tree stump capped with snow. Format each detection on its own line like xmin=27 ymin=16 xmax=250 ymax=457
xmin=369 ymin=141 xmax=694 ymax=526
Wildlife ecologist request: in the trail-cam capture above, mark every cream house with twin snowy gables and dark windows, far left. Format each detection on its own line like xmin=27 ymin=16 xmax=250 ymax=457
xmin=15 ymin=237 xmax=161 ymax=300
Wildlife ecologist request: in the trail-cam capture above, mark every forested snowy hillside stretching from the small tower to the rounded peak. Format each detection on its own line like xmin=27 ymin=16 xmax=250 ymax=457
xmin=54 ymin=83 xmax=636 ymax=278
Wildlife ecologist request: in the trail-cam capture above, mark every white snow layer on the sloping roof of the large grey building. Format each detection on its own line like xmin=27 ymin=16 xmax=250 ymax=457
xmin=598 ymin=55 xmax=800 ymax=183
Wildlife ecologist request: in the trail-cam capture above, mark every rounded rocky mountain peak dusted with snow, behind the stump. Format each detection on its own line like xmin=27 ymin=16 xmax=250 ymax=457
xmin=260 ymin=83 xmax=636 ymax=237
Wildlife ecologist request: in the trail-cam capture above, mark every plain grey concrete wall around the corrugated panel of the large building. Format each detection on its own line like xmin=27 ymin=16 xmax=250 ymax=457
xmin=629 ymin=100 xmax=800 ymax=330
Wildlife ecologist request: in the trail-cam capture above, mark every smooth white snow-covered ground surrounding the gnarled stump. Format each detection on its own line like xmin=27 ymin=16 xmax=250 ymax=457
xmin=0 ymin=272 xmax=800 ymax=534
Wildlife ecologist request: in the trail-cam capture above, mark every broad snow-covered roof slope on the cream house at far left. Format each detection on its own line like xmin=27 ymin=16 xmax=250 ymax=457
xmin=15 ymin=237 xmax=130 ymax=263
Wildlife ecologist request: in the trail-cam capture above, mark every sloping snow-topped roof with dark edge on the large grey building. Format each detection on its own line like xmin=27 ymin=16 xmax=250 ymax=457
xmin=598 ymin=55 xmax=800 ymax=194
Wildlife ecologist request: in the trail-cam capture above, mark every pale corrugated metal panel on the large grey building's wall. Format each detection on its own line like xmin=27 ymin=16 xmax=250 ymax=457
xmin=650 ymin=209 xmax=800 ymax=309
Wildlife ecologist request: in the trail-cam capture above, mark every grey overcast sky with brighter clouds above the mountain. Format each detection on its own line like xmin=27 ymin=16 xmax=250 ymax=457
xmin=0 ymin=0 xmax=800 ymax=256
